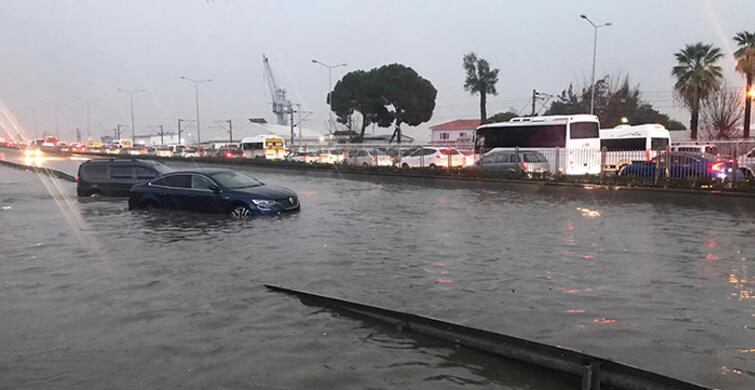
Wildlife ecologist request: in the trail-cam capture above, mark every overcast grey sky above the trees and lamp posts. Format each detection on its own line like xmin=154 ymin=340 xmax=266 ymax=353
xmin=0 ymin=0 xmax=755 ymax=140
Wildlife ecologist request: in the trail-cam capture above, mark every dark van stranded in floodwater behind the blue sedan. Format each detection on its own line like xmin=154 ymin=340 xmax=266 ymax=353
xmin=76 ymin=159 xmax=172 ymax=196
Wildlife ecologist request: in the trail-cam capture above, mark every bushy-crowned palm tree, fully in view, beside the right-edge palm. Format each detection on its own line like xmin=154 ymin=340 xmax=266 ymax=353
xmin=671 ymin=42 xmax=723 ymax=140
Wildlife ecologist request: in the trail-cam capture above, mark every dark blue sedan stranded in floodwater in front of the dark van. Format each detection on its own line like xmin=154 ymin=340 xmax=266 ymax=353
xmin=128 ymin=169 xmax=301 ymax=218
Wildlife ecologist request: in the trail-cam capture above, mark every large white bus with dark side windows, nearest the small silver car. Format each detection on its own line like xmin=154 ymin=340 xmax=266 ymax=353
xmin=475 ymin=114 xmax=600 ymax=175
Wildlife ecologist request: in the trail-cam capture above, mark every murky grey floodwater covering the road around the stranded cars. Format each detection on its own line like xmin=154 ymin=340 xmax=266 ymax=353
xmin=0 ymin=150 xmax=755 ymax=389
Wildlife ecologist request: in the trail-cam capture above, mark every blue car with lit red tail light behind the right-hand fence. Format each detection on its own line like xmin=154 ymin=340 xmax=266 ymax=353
xmin=619 ymin=152 xmax=743 ymax=181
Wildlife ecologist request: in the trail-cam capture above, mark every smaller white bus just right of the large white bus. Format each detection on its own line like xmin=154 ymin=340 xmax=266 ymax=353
xmin=600 ymin=124 xmax=671 ymax=171
